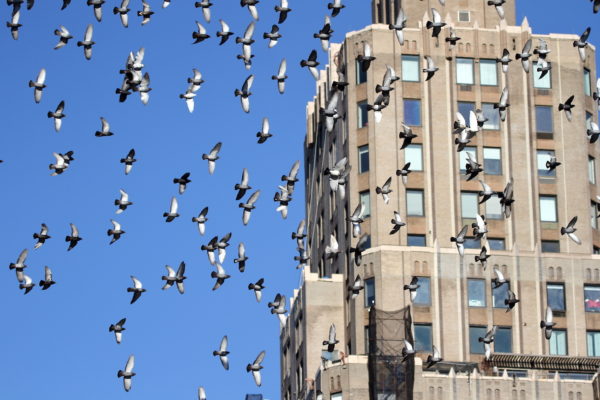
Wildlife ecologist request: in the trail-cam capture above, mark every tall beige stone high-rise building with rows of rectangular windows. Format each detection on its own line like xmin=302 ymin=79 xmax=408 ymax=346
xmin=280 ymin=0 xmax=600 ymax=400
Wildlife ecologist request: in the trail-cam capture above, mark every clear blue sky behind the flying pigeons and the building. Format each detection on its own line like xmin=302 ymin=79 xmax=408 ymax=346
xmin=0 ymin=0 xmax=600 ymax=400
